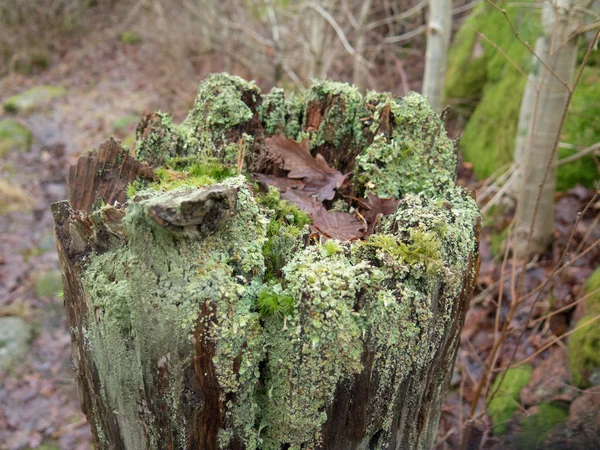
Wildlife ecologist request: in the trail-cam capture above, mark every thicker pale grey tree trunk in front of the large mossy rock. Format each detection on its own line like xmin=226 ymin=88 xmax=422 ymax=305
xmin=514 ymin=0 xmax=589 ymax=258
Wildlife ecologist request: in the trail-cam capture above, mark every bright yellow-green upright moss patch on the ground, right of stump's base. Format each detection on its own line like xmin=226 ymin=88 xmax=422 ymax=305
xmin=487 ymin=365 xmax=533 ymax=435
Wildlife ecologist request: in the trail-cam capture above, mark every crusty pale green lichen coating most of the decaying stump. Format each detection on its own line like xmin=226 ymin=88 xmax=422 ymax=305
xmin=74 ymin=75 xmax=478 ymax=450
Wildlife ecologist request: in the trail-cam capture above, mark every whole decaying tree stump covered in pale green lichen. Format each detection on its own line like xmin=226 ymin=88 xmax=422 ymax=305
xmin=52 ymin=75 xmax=479 ymax=450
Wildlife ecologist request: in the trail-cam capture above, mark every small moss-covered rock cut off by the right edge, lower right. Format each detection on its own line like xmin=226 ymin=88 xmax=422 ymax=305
xmin=568 ymin=269 xmax=600 ymax=389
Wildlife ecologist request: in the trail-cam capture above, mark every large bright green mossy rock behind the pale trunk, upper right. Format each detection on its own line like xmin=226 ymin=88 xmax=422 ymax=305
xmin=445 ymin=0 xmax=600 ymax=191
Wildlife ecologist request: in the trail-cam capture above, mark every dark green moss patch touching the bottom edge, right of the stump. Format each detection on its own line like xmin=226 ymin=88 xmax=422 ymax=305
xmin=515 ymin=403 xmax=569 ymax=450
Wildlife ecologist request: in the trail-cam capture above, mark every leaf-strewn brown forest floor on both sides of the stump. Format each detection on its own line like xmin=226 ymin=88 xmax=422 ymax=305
xmin=0 ymin=29 xmax=600 ymax=450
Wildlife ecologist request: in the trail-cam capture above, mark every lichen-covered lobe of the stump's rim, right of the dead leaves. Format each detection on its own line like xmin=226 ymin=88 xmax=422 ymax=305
xmin=355 ymin=93 xmax=456 ymax=198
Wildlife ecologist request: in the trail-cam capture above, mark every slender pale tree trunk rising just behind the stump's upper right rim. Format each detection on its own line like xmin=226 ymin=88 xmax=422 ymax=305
xmin=423 ymin=0 xmax=452 ymax=112
